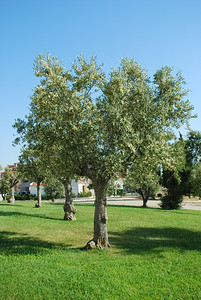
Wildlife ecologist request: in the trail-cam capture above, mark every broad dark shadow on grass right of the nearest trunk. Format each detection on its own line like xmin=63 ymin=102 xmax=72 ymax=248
xmin=110 ymin=227 xmax=201 ymax=255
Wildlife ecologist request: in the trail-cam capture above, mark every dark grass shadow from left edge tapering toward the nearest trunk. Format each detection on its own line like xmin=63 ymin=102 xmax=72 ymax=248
xmin=0 ymin=231 xmax=72 ymax=255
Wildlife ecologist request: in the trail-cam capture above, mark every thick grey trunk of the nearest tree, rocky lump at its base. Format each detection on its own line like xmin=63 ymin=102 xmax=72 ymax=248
xmin=85 ymin=179 xmax=110 ymax=249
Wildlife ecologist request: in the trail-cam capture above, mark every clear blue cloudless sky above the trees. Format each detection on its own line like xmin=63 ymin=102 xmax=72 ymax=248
xmin=0 ymin=0 xmax=201 ymax=167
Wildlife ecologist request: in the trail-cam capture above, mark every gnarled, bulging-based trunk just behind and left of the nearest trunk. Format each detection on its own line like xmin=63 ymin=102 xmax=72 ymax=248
xmin=63 ymin=181 xmax=77 ymax=221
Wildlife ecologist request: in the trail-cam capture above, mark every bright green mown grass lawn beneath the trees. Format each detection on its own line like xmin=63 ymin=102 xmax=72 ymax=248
xmin=0 ymin=201 xmax=201 ymax=300
